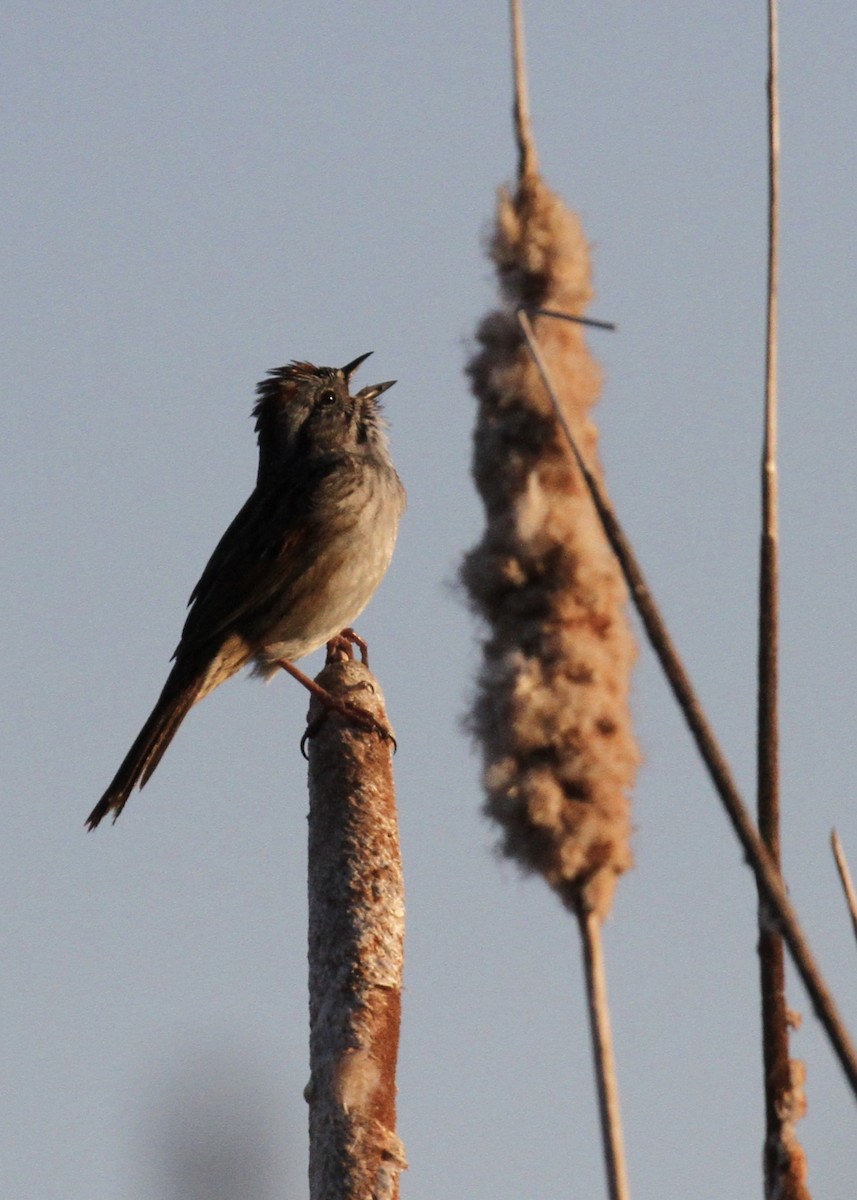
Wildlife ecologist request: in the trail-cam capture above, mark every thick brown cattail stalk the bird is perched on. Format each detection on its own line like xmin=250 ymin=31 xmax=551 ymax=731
xmin=306 ymin=656 xmax=407 ymax=1200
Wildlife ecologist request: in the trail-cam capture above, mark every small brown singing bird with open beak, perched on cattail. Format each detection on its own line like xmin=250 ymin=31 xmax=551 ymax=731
xmin=86 ymin=350 xmax=406 ymax=829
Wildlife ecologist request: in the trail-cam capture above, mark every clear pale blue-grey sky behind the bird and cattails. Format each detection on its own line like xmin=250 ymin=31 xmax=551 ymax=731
xmin=0 ymin=0 xmax=857 ymax=1200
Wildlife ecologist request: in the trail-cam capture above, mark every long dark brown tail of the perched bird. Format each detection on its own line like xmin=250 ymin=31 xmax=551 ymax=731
xmin=86 ymin=662 xmax=210 ymax=829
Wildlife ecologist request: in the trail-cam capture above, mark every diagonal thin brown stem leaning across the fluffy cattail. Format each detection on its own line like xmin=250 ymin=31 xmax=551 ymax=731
xmin=517 ymin=312 xmax=857 ymax=1098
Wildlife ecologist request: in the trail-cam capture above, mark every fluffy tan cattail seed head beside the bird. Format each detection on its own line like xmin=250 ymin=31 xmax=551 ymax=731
xmin=462 ymin=169 xmax=639 ymax=917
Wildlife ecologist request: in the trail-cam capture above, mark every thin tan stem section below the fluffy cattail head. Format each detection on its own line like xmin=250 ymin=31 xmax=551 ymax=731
xmin=577 ymin=910 xmax=630 ymax=1200
